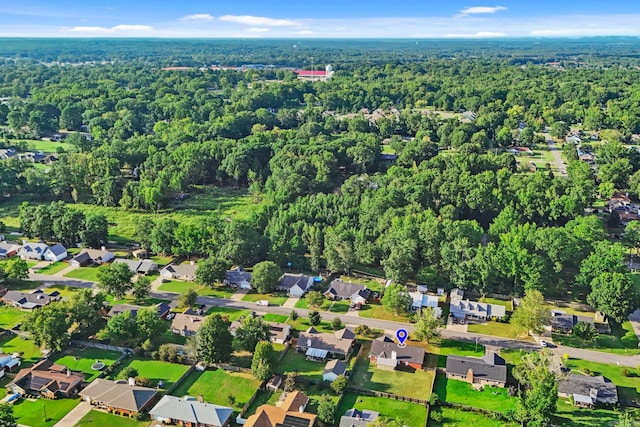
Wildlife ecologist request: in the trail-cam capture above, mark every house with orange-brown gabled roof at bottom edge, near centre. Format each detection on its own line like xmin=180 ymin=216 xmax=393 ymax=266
xmin=244 ymin=390 xmax=317 ymax=427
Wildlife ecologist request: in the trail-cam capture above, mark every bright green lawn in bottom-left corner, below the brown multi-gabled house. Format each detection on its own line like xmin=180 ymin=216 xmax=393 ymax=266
xmin=13 ymin=399 xmax=80 ymax=427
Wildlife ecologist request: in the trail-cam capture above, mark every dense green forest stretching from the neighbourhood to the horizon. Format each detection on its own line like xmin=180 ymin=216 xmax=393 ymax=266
xmin=0 ymin=39 xmax=640 ymax=320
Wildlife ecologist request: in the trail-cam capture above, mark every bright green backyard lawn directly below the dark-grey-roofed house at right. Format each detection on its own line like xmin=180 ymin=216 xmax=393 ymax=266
xmin=433 ymin=373 xmax=516 ymax=413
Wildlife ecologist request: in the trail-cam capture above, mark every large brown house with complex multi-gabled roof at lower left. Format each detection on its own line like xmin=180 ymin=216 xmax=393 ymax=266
xmin=7 ymin=359 xmax=84 ymax=399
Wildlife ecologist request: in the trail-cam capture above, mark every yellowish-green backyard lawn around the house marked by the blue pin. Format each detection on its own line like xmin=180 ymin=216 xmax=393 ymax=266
xmin=351 ymin=342 xmax=434 ymax=400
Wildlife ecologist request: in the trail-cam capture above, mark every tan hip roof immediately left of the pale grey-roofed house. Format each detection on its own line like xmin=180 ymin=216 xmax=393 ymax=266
xmin=80 ymin=378 xmax=158 ymax=412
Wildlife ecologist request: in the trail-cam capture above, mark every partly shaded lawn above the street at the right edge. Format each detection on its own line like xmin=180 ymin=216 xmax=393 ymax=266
xmin=553 ymin=321 xmax=640 ymax=355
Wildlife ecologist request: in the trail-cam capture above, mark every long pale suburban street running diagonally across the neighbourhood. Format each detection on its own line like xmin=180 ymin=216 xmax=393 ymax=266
xmin=29 ymin=273 xmax=640 ymax=368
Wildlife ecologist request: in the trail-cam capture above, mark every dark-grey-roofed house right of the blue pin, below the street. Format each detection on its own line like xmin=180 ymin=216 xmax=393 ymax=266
xmin=446 ymin=352 xmax=507 ymax=387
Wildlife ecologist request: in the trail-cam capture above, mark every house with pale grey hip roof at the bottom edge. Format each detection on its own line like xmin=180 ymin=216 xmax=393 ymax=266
xmin=149 ymin=395 xmax=233 ymax=427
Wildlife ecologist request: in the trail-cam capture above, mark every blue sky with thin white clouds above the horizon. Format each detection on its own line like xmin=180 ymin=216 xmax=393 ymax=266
xmin=0 ymin=0 xmax=640 ymax=38
